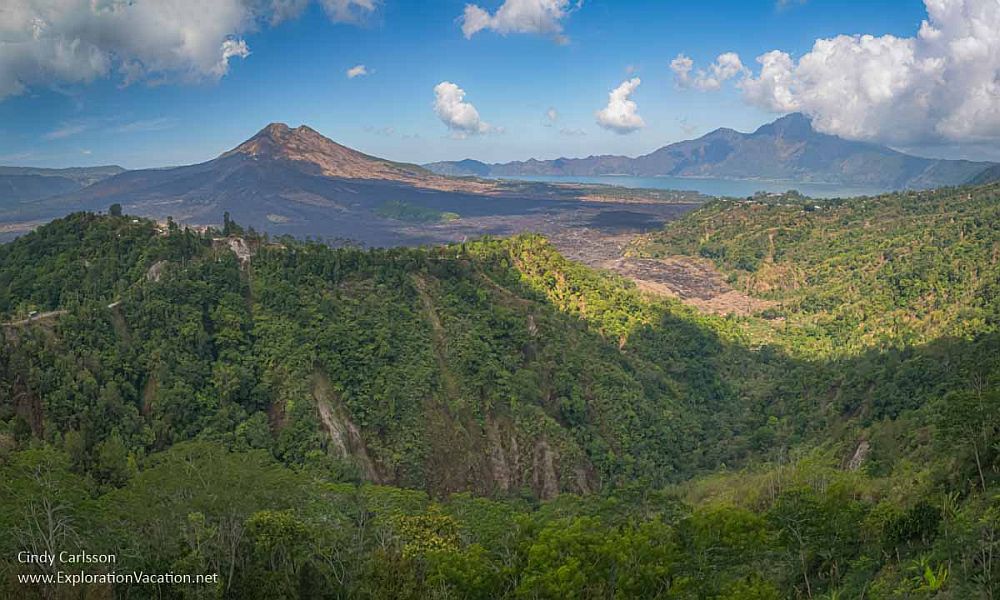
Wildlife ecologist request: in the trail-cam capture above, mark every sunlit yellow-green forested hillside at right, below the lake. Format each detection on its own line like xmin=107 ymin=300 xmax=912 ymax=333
xmin=633 ymin=184 xmax=1000 ymax=353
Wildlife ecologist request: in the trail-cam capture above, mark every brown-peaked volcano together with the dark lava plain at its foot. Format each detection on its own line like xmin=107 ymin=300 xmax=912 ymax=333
xmin=0 ymin=124 xmax=700 ymax=246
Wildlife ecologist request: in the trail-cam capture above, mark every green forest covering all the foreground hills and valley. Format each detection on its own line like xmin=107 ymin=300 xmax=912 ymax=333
xmin=0 ymin=184 xmax=1000 ymax=600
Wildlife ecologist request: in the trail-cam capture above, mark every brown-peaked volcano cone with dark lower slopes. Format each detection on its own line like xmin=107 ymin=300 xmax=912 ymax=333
xmin=5 ymin=124 xmax=492 ymax=223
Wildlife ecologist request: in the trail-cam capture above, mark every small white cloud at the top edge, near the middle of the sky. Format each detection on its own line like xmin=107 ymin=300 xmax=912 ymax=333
xmin=460 ymin=0 xmax=583 ymax=43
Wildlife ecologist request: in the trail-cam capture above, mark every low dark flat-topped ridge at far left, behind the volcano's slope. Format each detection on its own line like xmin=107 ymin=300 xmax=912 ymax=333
xmin=0 ymin=165 xmax=125 ymax=207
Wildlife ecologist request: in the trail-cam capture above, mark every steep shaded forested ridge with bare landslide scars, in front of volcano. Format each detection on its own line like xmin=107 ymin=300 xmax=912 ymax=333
xmin=0 ymin=215 xmax=752 ymax=498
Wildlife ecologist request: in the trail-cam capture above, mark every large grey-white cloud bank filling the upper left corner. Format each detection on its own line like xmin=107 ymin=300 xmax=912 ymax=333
xmin=0 ymin=0 xmax=377 ymax=99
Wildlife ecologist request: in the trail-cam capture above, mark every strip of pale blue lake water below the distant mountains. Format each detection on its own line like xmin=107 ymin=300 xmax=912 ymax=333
xmin=488 ymin=175 xmax=889 ymax=198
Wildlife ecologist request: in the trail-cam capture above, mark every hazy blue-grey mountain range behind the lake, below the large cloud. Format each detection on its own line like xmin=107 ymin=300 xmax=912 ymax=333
xmin=424 ymin=113 xmax=997 ymax=189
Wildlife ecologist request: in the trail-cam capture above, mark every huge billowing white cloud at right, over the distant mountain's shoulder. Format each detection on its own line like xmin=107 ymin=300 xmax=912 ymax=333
xmin=739 ymin=0 xmax=1000 ymax=146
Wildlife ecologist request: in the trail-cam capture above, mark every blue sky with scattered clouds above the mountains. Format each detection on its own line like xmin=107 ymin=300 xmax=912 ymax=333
xmin=0 ymin=0 xmax=1000 ymax=169
